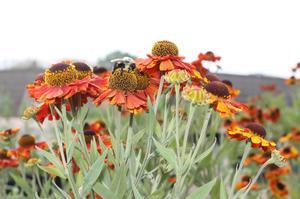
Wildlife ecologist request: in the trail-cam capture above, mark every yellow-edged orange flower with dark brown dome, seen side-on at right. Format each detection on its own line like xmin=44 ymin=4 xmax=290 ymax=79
xmin=227 ymin=123 xmax=276 ymax=151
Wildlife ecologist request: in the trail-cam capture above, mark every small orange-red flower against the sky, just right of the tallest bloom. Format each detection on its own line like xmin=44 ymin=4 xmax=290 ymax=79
xmin=192 ymin=51 xmax=221 ymax=77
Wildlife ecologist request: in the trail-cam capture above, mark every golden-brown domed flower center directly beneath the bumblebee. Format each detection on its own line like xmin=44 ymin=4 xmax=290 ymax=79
xmin=109 ymin=68 xmax=137 ymax=91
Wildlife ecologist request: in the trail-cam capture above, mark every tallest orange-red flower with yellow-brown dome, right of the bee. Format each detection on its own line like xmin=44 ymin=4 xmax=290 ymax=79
xmin=136 ymin=40 xmax=196 ymax=74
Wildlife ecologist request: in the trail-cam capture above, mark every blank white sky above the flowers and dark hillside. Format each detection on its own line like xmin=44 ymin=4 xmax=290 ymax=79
xmin=0 ymin=0 xmax=300 ymax=77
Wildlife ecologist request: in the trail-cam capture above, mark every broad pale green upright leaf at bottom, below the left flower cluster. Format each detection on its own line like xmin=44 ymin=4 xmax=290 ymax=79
xmin=81 ymin=151 xmax=107 ymax=196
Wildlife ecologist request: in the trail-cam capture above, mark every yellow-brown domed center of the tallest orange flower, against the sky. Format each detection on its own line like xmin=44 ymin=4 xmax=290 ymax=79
xmin=152 ymin=40 xmax=178 ymax=57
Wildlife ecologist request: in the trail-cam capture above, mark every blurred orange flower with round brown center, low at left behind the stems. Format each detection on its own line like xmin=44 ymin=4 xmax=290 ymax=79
xmin=10 ymin=134 xmax=48 ymax=160
